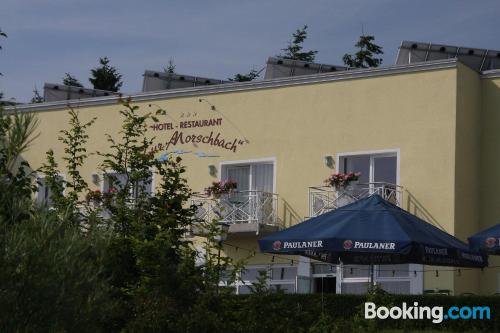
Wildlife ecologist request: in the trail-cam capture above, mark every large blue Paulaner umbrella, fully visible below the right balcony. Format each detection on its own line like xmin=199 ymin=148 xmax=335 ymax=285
xmin=259 ymin=195 xmax=487 ymax=267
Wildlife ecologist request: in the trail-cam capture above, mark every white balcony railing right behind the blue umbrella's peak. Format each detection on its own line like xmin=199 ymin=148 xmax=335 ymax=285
xmin=309 ymin=182 xmax=403 ymax=217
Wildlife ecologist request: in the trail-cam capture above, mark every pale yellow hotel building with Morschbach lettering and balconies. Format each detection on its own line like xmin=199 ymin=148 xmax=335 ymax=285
xmin=9 ymin=40 xmax=500 ymax=294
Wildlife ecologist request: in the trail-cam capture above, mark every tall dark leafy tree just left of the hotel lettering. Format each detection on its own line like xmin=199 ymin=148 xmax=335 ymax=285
xmin=94 ymin=101 xmax=203 ymax=332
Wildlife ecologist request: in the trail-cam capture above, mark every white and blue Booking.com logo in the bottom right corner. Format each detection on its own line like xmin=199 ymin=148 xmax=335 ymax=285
xmin=365 ymin=302 xmax=491 ymax=324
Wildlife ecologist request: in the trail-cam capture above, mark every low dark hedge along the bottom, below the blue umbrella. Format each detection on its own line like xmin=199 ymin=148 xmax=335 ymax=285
xmin=186 ymin=294 xmax=500 ymax=333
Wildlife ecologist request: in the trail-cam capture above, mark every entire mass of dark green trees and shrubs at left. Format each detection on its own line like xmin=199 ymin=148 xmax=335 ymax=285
xmin=0 ymin=96 xmax=246 ymax=332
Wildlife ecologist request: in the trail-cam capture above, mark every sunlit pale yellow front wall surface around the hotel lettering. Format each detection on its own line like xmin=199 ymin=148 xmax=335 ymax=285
xmin=21 ymin=68 xmax=472 ymax=290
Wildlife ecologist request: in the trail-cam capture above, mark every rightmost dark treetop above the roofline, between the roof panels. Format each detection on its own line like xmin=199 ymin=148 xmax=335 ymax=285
xmin=342 ymin=35 xmax=384 ymax=68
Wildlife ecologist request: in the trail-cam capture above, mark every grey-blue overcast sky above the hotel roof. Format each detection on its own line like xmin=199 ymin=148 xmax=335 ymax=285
xmin=0 ymin=0 xmax=500 ymax=102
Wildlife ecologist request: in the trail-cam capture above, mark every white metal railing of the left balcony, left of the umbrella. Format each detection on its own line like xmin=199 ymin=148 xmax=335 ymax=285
xmin=191 ymin=191 xmax=278 ymax=225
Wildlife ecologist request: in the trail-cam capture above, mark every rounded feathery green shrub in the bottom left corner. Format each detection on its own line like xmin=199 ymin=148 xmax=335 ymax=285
xmin=0 ymin=208 xmax=112 ymax=332
